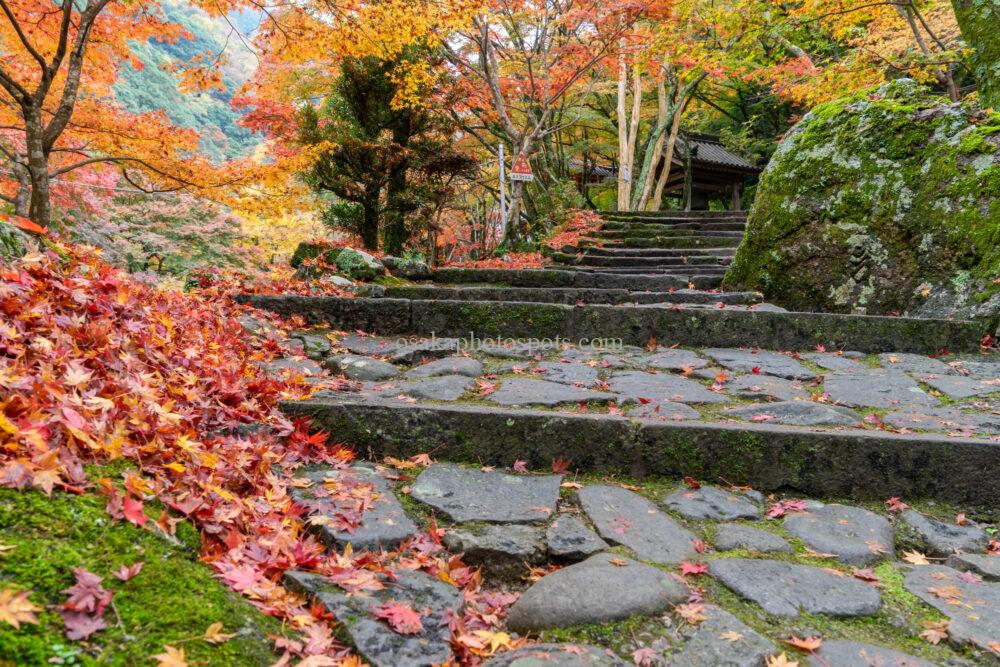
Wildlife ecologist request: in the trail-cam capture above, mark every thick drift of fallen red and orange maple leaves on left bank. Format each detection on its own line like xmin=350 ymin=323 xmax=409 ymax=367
xmin=0 ymin=242 xmax=511 ymax=666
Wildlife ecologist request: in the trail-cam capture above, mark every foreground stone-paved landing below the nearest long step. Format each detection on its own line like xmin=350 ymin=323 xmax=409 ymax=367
xmin=276 ymin=460 xmax=1000 ymax=667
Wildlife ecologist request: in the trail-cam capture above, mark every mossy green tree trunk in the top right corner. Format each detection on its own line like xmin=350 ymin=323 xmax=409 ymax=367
xmin=951 ymin=0 xmax=1000 ymax=109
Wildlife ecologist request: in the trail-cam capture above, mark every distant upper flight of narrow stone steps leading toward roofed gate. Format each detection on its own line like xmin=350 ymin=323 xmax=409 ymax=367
xmin=552 ymin=211 xmax=746 ymax=288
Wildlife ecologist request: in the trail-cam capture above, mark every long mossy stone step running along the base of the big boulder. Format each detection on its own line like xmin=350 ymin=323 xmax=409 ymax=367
xmin=239 ymin=294 xmax=992 ymax=354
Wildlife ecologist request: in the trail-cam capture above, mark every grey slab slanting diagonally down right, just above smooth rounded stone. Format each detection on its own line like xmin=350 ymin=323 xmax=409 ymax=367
xmin=577 ymin=484 xmax=697 ymax=564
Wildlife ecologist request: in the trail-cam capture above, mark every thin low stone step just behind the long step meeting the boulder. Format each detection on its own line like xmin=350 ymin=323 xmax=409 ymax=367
xmin=386 ymin=286 xmax=761 ymax=305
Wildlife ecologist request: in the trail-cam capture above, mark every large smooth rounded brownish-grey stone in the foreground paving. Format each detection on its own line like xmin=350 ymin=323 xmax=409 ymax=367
xmin=507 ymin=554 xmax=688 ymax=632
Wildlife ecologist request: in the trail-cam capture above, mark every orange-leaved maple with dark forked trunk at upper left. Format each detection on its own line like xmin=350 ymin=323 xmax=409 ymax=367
xmin=0 ymin=0 xmax=262 ymax=226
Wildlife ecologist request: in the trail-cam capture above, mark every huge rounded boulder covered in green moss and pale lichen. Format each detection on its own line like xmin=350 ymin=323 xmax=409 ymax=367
xmin=725 ymin=79 xmax=1000 ymax=318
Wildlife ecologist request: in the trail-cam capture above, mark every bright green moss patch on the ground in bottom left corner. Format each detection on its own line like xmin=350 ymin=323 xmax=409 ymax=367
xmin=0 ymin=482 xmax=281 ymax=666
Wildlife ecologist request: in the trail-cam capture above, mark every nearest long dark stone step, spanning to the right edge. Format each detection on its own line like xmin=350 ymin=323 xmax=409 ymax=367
xmin=281 ymin=392 xmax=1000 ymax=507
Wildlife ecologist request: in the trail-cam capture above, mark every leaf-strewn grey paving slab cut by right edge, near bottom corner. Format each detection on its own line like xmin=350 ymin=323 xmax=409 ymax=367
xmin=903 ymin=565 xmax=1000 ymax=651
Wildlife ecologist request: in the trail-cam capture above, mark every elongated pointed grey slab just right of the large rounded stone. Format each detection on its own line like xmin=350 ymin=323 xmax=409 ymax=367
xmin=708 ymin=558 xmax=882 ymax=617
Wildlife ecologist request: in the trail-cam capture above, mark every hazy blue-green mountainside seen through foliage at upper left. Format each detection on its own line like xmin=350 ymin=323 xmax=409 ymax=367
xmin=115 ymin=0 xmax=260 ymax=161
